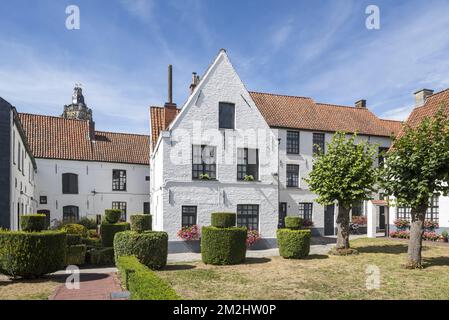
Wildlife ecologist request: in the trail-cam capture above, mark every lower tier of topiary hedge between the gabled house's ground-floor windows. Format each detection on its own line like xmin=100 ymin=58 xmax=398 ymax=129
xmin=201 ymin=226 xmax=247 ymax=265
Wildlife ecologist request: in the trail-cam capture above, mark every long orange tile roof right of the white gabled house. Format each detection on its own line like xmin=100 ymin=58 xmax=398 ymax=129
xmin=250 ymin=92 xmax=400 ymax=137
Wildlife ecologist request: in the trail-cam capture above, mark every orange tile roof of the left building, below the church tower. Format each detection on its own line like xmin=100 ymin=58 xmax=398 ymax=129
xmin=19 ymin=113 xmax=150 ymax=165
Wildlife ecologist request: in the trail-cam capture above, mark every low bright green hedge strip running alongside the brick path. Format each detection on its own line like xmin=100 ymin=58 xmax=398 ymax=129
xmin=117 ymin=256 xmax=180 ymax=300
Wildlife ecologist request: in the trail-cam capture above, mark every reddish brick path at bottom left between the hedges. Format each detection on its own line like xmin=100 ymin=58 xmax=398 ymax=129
xmin=50 ymin=273 xmax=123 ymax=300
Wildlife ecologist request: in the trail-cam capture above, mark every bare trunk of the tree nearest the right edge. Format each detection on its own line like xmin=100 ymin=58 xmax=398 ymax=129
xmin=406 ymin=202 xmax=428 ymax=269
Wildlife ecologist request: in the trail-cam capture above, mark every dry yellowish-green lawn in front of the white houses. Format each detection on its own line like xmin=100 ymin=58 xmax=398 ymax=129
xmin=158 ymin=238 xmax=449 ymax=300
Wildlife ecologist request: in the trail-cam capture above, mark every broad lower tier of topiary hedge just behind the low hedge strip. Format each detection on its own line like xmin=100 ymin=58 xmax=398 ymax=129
xmin=114 ymin=231 xmax=168 ymax=270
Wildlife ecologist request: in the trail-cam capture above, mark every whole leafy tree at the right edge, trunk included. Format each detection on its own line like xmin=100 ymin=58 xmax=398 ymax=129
xmin=381 ymin=106 xmax=449 ymax=268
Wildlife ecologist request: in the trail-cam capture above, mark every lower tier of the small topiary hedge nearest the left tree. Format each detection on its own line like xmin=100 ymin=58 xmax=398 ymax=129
xmin=276 ymin=229 xmax=311 ymax=259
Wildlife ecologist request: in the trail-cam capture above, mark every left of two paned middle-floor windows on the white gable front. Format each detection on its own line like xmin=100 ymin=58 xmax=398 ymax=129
xmin=192 ymin=145 xmax=216 ymax=179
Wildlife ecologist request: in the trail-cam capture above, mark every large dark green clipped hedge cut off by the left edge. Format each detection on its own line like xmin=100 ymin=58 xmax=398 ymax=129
xmin=0 ymin=231 xmax=67 ymax=279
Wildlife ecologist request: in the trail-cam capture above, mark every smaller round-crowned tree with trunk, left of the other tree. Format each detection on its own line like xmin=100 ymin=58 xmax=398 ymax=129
xmin=306 ymin=132 xmax=377 ymax=251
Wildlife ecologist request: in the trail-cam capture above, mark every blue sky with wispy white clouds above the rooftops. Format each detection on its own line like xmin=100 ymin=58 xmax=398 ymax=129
xmin=0 ymin=0 xmax=449 ymax=133
